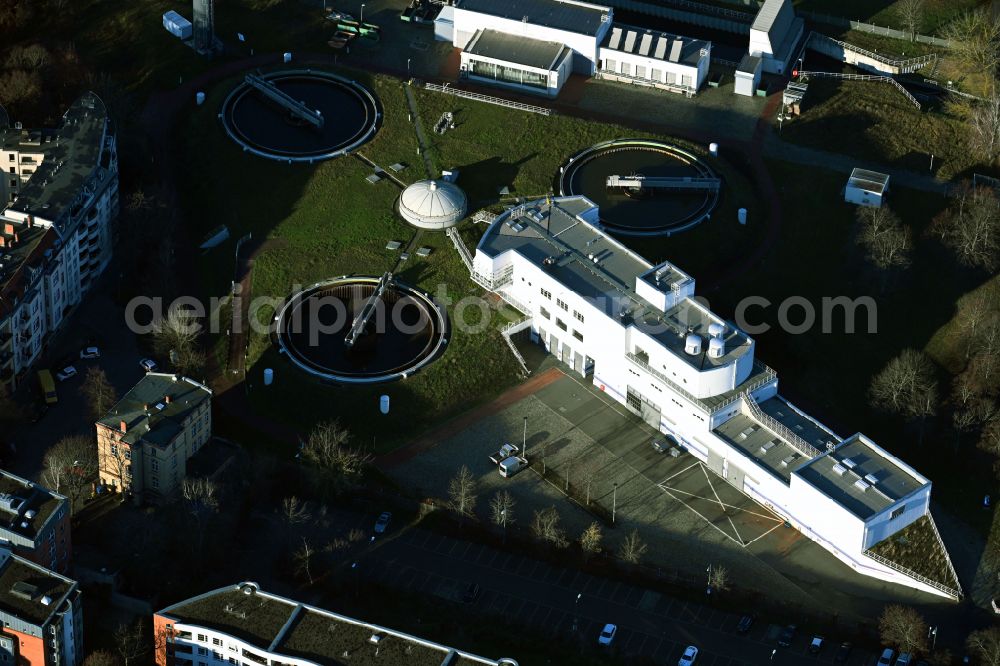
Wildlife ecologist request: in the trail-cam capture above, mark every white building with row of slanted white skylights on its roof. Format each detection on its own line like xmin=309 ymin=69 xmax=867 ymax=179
xmin=597 ymin=23 xmax=712 ymax=95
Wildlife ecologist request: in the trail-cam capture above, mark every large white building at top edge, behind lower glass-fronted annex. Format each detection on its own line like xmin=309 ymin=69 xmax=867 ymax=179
xmin=452 ymin=0 xmax=612 ymax=76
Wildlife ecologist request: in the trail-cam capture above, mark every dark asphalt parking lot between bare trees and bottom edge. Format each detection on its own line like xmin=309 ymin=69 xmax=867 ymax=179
xmin=361 ymin=529 xmax=875 ymax=666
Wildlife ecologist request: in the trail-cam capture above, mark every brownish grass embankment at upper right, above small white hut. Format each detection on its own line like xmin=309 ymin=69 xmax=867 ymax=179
xmin=781 ymin=79 xmax=976 ymax=179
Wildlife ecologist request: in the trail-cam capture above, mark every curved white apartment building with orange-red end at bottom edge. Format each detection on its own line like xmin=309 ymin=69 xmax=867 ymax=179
xmin=153 ymin=582 xmax=517 ymax=666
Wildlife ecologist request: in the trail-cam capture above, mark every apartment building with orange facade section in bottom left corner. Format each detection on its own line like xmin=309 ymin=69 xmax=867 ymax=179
xmin=0 ymin=550 xmax=83 ymax=666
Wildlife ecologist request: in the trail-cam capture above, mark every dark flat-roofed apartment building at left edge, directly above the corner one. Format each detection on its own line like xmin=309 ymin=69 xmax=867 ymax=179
xmin=0 ymin=470 xmax=73 ymax=573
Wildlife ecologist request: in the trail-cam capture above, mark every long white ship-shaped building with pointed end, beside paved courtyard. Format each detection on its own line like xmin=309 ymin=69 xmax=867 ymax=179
xmin=472 ymin=197 xmax=956 ymax=594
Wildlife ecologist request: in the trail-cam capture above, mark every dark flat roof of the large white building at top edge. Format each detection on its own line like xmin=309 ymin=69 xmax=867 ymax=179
xmin=455 ymin=0 xmax=611 ymax=37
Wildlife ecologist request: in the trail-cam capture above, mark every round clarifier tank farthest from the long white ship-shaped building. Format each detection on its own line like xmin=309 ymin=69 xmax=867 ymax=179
xmin=219 ymin=70 xmax=382 ymax=162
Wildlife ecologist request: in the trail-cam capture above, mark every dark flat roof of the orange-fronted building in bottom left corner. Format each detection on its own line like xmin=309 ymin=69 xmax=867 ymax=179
xmin=0 ymin=551 xmax=76 ymax=627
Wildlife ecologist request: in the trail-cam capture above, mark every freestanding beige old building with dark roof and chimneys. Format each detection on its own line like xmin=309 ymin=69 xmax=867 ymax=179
xmin=96 ymin=372 xmax=212 ymax=503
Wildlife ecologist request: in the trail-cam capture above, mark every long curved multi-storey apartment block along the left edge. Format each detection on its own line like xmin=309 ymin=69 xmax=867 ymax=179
xmin=0 ymin=93 xmax=118 ymax=395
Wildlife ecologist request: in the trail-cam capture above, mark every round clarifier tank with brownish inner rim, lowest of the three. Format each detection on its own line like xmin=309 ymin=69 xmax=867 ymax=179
xmin=277 ymin=276 xmax=449 ymax=384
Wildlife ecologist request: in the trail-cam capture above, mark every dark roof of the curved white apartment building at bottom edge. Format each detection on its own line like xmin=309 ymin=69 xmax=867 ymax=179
xmin=157 ymin=583 xmax=516 ymax=666
